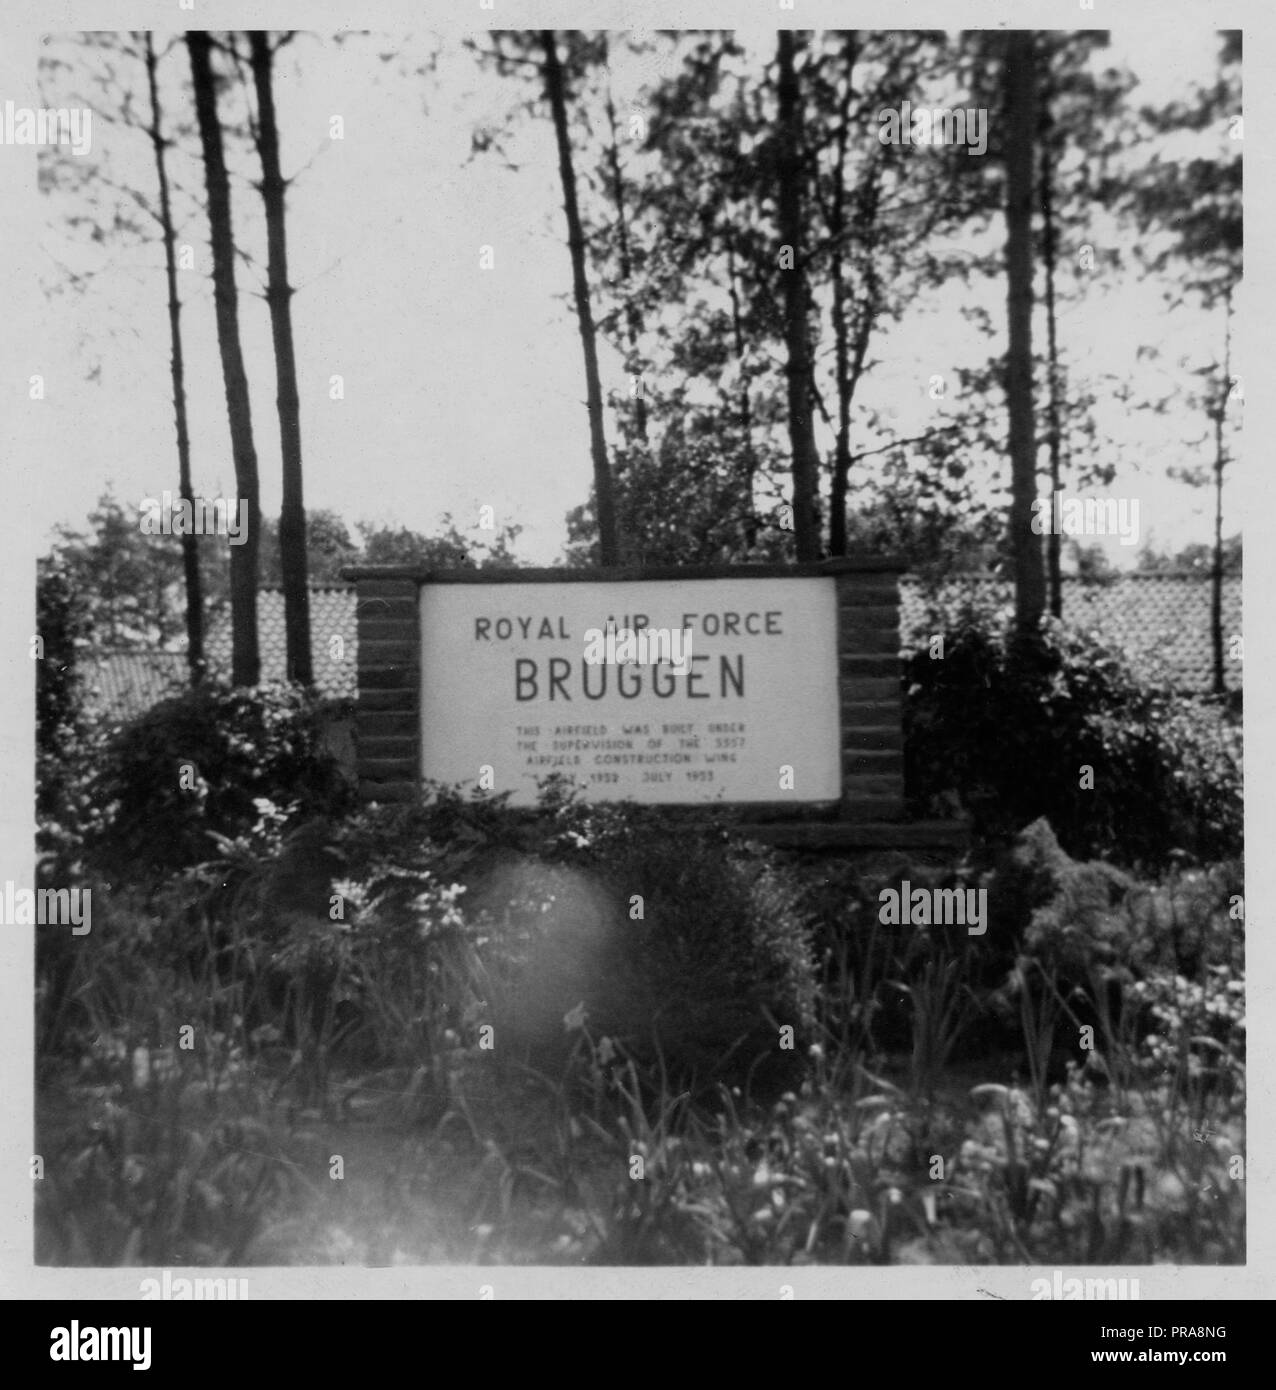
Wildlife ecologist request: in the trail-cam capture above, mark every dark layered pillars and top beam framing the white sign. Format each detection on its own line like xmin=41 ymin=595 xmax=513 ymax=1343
xmin=343 ymin=559 xmax=960 ymax=848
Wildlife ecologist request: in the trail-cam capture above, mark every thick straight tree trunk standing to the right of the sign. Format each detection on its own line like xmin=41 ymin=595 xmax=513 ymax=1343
xmin=1002 ymin=29 xmax=1045 ymax=638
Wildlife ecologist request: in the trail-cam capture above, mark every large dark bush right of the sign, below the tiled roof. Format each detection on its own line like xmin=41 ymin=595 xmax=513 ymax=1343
xmin=905 ymin=612 xmax=1243 ymax=866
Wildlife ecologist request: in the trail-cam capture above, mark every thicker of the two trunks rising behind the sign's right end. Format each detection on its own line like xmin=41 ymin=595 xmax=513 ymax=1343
xmin=777 ymin=29 xmax=820 ymax=563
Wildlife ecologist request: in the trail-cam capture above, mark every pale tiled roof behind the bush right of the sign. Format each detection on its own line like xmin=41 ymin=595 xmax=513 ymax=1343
xmin=899 ymin=571 xmax=1241 ymax=692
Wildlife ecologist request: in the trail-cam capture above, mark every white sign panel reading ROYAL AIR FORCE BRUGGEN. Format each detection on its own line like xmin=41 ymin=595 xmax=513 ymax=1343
xmin=421 ymin=578 xmax=841 ymax=805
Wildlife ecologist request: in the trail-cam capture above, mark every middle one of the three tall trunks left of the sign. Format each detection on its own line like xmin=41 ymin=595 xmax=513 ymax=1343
xmin=186 ymin=29 xmax=261 ymax=685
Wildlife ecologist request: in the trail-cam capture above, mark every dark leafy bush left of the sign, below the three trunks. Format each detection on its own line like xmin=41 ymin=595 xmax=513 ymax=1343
xmin=86 ymin=682 xmax=353 ymax=876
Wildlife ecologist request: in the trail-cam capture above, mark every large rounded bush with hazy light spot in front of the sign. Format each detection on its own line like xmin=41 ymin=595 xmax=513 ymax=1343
xmin=314 ymin=784 xmax=815 ymax=1084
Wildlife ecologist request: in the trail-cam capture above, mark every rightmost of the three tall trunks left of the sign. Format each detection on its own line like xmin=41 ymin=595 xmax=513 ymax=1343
xmin=249 ymin=29 xmax=314 ymax=685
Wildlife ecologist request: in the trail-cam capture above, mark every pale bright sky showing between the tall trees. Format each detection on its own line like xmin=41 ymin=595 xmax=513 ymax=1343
xmin=35 ymin=17 xmax=1238 ymax=563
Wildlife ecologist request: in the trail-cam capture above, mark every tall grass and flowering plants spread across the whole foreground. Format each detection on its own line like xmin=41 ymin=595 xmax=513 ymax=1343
xmin=36 ymin=800 xmax=1245 ymax=1266
